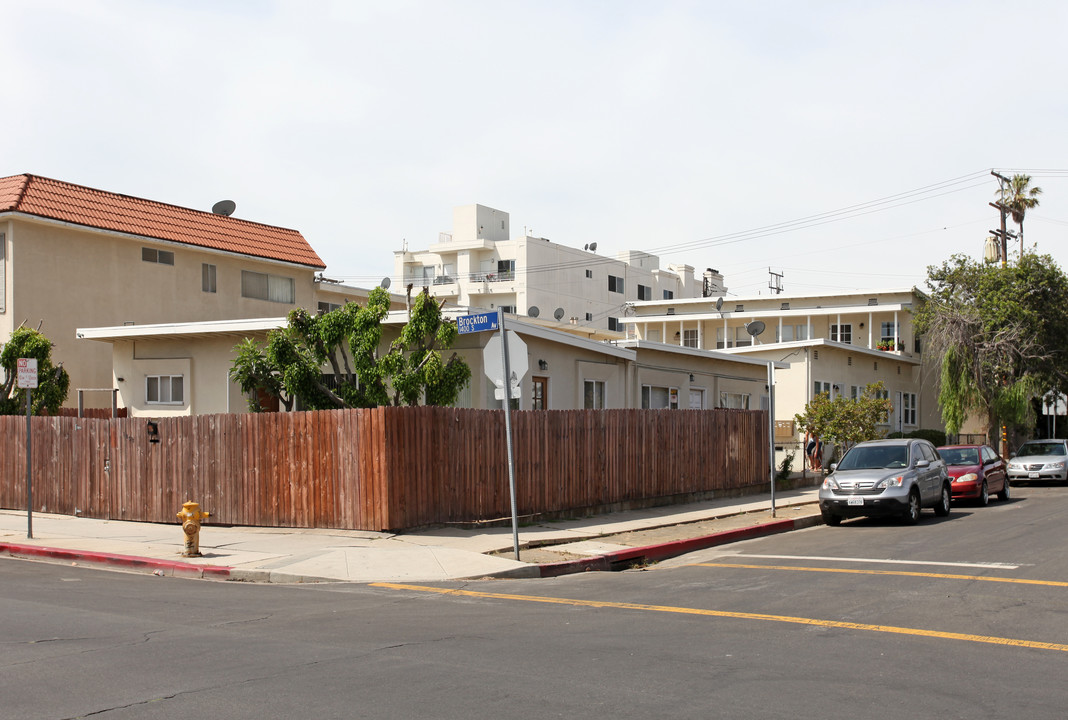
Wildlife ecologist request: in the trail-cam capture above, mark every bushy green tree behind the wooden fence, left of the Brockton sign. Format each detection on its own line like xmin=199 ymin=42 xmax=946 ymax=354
xmin=230 ymin=287 xmax=471 ymax=410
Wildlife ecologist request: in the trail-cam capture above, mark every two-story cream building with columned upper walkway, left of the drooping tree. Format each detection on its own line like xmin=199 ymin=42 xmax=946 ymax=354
xmin=625 ymin=288 xmax=942 ymax=467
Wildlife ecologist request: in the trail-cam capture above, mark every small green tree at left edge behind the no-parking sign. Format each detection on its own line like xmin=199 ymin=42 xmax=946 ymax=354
xmin=0 ymin=326 xmax=70 ymax=414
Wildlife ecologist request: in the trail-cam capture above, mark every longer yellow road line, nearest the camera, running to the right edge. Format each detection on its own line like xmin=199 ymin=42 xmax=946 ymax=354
xmin=371 ymin=582 xmax=1068 ymax=653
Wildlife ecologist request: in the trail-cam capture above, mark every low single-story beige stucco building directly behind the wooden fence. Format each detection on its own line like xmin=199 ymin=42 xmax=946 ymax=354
xmin=78 ymin=310 xmax=785 ymax=417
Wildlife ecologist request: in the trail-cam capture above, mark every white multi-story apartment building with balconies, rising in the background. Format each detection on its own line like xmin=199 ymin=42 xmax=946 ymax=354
xmin=394 ymin=205 xmax=726 ymax=333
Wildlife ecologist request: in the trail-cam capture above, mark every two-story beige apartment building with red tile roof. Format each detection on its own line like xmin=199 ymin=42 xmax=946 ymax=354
xmin=0 ymin=174 xmax=328 ymax=407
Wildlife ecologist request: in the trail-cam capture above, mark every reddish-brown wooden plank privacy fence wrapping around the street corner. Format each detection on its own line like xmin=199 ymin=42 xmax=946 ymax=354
xmin=0 ymin=407 xmax=768 ymax=530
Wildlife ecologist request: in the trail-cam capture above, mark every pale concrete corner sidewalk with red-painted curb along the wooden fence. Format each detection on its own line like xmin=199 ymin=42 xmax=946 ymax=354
xmin=0 ymin=487 xmax=819 ymax=582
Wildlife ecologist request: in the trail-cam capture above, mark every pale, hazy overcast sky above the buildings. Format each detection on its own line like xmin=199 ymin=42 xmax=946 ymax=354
xmin=0 ymin=0 xmax=1068 ymax=296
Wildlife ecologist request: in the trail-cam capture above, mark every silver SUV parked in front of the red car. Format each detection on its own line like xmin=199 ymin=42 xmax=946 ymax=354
xmin=819 ymin=438 xmax=953 ymax=526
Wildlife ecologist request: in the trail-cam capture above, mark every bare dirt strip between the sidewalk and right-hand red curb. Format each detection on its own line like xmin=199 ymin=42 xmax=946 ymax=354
xmin=489 ymin=503 xmax=819 ymax=564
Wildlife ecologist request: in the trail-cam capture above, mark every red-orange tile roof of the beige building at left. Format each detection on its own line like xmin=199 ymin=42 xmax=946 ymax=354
xmin=0 ymin=175 xmax=326 ymax=269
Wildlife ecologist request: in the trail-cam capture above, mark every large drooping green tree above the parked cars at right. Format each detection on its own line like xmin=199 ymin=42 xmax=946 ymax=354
xmin=915 ymin=254 xmax=1068 ymax=438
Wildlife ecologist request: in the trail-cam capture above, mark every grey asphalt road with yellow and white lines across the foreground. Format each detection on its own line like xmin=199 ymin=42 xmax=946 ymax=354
xmin=0 ymin=487 xmax=1068 ymax=720
